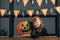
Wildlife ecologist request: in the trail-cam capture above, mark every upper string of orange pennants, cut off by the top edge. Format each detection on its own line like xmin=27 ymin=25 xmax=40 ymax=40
xmin=9 ymin=0 xmax=56 ymax=7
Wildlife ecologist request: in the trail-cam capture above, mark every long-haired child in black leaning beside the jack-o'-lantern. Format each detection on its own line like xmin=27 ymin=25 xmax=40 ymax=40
xmin=31 ymin=17 xmax=47 ymax=38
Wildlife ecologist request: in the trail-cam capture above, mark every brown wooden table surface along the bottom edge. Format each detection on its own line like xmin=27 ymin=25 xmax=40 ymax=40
xmin=0 ymin=36 xmax=60 ymax=40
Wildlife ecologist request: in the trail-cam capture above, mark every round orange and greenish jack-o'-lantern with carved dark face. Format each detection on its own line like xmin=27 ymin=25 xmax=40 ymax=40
xmin=16 ymin=20 xmax=31 ymax=35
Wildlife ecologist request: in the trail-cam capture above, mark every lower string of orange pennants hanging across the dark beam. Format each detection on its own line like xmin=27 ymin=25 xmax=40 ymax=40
xmin=0 ymin=6 xmax=60 ymax=17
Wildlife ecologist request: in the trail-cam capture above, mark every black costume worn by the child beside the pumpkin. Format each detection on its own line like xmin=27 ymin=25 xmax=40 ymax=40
xmin=31 ymin=27 xmax=48 ymax=38
